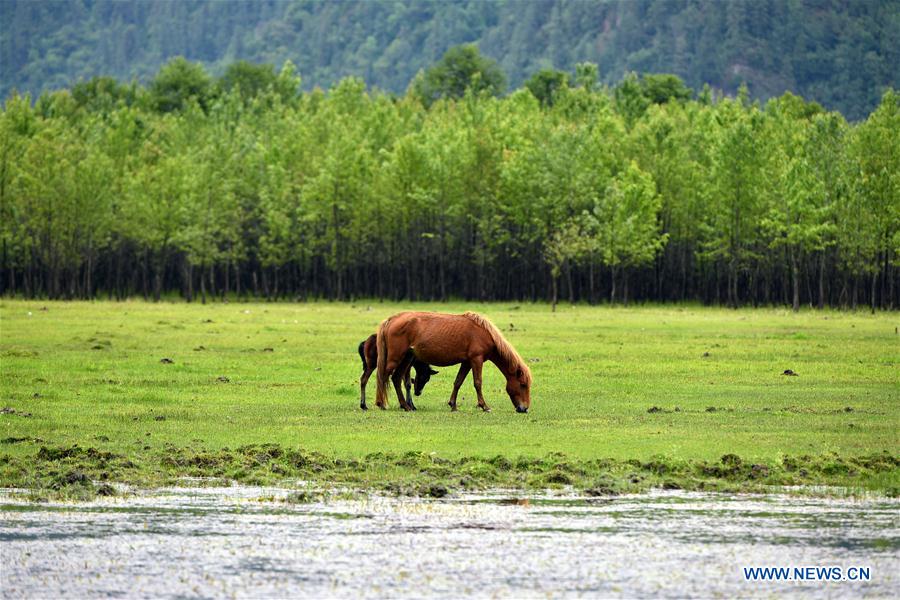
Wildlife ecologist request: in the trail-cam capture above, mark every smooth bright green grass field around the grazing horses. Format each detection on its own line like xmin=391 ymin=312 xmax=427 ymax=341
xmin=0 ymin=300 xmax=900 ymax=496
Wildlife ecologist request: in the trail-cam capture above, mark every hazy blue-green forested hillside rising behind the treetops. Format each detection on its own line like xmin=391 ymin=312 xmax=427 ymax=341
xmin=0 ymin=0 xmax=900 ymax=119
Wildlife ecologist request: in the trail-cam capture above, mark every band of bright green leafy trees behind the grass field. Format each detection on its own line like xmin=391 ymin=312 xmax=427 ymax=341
xmin=0 ymin=46 xmax=900 ymax=310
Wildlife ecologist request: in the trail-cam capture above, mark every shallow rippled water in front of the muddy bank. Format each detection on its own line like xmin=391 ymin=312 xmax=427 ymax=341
xmin=0 ymin=487 xmax=900 ymax=598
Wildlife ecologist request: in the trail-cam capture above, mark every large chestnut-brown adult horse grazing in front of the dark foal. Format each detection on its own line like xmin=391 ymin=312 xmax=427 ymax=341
xmin=375 ymin=312 xmax=531 ymax=413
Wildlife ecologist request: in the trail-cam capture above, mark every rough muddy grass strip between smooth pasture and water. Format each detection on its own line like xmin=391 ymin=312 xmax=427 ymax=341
xmin=0 ymin=444 xmax=900 ymax=501
